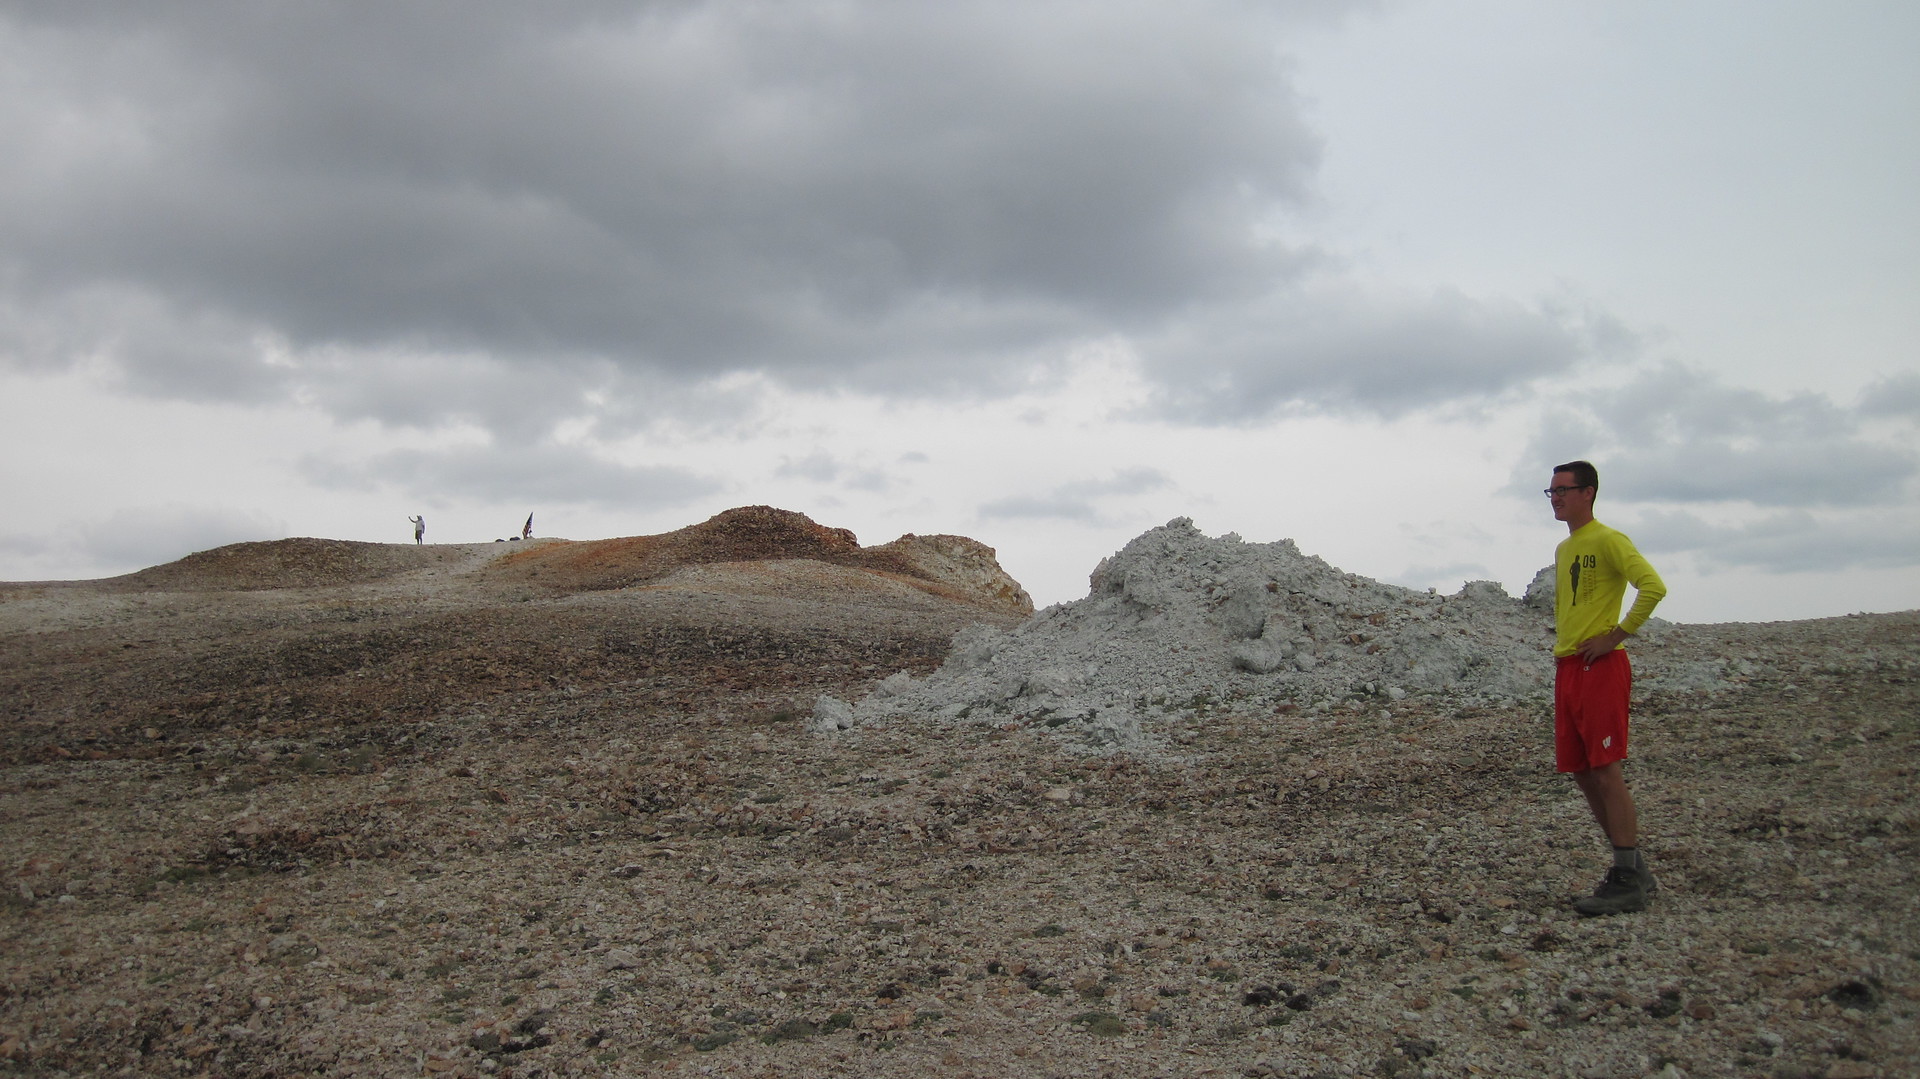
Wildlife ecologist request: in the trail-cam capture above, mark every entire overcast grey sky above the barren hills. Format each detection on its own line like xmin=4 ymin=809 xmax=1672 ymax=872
xmin=0 ymin=0 xmax=1920 ymax=622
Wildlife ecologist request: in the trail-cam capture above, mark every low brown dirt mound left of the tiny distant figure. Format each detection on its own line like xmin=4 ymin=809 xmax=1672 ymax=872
xmin=100 ymin=538 xmax=480 ymax=591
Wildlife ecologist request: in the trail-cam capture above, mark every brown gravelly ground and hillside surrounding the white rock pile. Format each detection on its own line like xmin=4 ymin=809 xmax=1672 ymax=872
xmin=0 ymin=511 xmax=1920 ymax=1077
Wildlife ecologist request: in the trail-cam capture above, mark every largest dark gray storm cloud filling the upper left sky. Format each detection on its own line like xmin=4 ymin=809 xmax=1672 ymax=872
xmin=0 ymin=2 xmax=1578 ymax=436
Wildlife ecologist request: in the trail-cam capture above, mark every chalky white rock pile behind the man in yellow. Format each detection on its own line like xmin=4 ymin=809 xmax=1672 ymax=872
xmin=814 ymin=516 xmax=1722 ymax=749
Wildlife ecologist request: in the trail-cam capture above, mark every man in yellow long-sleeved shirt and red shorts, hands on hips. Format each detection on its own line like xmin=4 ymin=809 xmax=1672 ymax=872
xmin=1546 ymin=461 xmax=1667 ymax=916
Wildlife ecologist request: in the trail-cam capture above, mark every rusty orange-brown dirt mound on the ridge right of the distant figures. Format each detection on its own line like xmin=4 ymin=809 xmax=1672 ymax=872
xmin=488 ymin=505 xmax=1033 ymax=614
